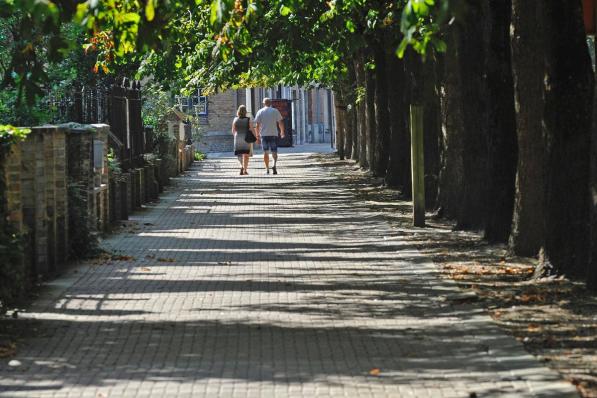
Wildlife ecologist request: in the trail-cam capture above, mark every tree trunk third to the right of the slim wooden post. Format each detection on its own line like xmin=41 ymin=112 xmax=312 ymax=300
xmin=510 ymin=0 xmax=545 ymax=256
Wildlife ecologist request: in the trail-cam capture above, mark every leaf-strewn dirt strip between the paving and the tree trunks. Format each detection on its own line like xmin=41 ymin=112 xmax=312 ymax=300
xmin=318 ymin=156 xmax=597 ymax=397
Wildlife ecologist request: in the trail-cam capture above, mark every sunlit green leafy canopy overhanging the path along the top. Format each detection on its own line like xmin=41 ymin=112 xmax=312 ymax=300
xmin=0 ymin=0 xmax=449 ymax=104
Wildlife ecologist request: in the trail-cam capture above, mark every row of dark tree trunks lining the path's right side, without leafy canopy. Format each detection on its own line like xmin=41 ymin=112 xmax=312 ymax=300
xmin=336 ymin=0 xmax=597 ymax=288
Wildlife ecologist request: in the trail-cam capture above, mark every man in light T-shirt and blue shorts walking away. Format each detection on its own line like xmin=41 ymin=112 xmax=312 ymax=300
xmin=255 ymin=98 xmax=286 ymax=174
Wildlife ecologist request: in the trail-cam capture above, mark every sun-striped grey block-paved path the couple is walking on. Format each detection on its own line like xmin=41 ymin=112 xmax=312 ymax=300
xmin=0 ymin=148 xmax=577 ymax=398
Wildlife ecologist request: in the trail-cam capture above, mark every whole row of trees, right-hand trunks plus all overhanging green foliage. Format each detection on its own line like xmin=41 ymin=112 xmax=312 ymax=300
xmin=0 ymin=0 xmax=597 ymax=288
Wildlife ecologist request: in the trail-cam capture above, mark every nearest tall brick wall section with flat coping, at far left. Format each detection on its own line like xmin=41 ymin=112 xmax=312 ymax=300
xmin=3 ymin=125 xmax=108 ymax=276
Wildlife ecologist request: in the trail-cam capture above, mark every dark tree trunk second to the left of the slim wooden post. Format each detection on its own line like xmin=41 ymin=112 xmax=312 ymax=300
xmin=372 ymin=42 xmax=391 ymax=177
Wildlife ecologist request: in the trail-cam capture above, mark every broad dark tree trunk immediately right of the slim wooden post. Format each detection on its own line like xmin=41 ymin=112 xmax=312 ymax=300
xmin=438 ymin=0 xmax=488 ymax=229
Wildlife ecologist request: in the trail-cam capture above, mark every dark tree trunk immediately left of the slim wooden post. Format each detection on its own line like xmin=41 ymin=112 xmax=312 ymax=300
xmin=386 ymin=53 xmax=412 ymax=192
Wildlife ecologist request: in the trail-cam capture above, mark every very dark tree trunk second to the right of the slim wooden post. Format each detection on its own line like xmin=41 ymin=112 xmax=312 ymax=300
xmin=485 ymin=0 xmax=518 ymax=243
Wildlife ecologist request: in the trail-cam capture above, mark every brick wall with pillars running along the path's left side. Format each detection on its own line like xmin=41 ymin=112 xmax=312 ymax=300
xmin=0 ymin=124 xmax=194 ymax=277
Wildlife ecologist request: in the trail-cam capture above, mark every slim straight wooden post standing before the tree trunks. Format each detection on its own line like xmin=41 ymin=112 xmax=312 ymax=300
xmin=410 ymin=105 xmax=425 ymax=227
